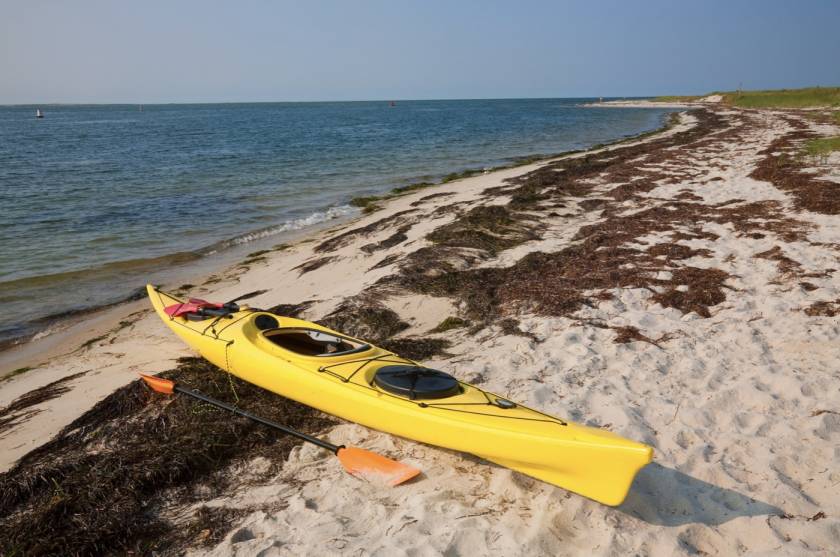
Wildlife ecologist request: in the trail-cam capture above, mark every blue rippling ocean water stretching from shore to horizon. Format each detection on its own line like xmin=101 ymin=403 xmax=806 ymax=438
xmin=0 ymin=99 xmax=670 ymax=341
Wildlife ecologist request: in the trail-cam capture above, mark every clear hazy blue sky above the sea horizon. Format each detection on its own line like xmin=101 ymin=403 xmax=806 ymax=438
xmin=0 ymin=0 xmax=840 ymax=104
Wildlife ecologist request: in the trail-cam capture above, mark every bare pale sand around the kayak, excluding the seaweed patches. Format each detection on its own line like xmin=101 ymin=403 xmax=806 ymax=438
xmin=0 ymin=106 xmax=840 ymax=556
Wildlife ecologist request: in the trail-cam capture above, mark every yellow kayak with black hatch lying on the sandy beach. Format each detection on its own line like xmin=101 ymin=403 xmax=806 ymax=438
xmin=147 ymin=285 xmax=653 ymax=505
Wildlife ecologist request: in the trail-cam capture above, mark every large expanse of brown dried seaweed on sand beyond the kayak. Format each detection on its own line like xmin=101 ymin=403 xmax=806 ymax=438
xmin=371 ymin=110 xmax=808 ymax=330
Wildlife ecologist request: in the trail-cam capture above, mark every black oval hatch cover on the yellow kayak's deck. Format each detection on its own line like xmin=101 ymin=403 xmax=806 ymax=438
xmin=373 ymin=365 xmax=461 ymax=400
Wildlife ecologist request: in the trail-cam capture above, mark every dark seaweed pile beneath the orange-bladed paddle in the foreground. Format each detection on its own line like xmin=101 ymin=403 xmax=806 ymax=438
xmin=0 ymin=358 xmax=334 ymax=555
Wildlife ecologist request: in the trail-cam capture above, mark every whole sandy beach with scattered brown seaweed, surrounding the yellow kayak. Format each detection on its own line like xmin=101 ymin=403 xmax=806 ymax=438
xmin=0 ymin=100 xmax=840 ymax=556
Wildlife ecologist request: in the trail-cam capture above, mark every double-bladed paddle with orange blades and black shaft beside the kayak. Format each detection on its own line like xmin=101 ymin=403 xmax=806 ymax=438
xmin=140 ymin=373 xmax=420 ymax=486
